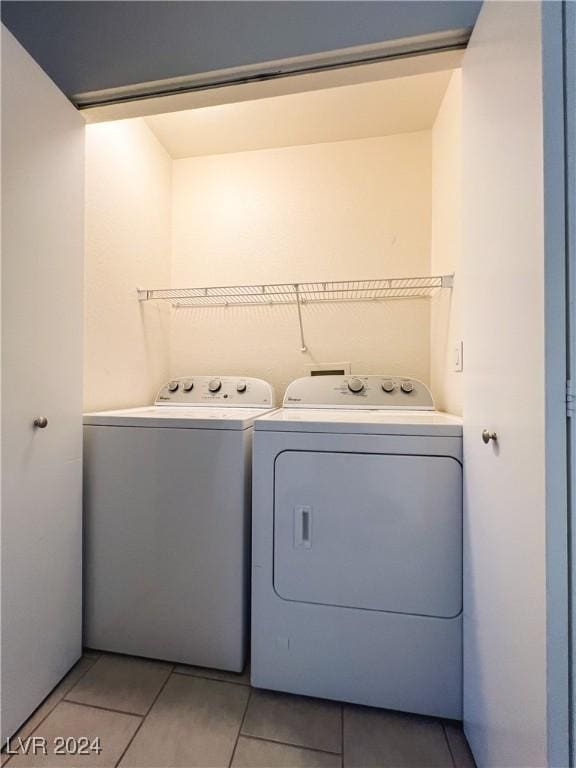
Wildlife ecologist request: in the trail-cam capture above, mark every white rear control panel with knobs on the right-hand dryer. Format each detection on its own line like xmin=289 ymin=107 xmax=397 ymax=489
xmin=284 ymin=374 xmax=434 ymax=411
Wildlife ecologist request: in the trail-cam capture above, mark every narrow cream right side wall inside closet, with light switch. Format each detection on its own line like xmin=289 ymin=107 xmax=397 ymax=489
xmin=430 ymin=70 xmax=463 ymax=415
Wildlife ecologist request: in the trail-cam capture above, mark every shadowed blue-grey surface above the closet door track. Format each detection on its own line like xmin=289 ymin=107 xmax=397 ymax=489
xmin=0 ymin=0 xmax=481 ymax=96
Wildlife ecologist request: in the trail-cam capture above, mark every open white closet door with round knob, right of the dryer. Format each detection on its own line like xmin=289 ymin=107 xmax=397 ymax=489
xmin=462 ymin=2 xmax=548 ymax=768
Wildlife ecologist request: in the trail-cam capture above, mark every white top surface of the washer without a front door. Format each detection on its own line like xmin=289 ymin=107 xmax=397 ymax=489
xmin=84 ymin=405 xmax=270 ymax=429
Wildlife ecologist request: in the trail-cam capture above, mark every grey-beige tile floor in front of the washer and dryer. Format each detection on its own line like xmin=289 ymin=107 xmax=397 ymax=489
xmin=2 ymin=652 xmax=474 ymax=768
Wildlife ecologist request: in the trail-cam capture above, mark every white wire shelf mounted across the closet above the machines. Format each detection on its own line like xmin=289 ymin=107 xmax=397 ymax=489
xmin=138 ymin=275 xmax=454 ymax=309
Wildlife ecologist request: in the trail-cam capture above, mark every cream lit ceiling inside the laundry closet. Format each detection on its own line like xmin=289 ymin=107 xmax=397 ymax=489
xmin=145 ymin=71 xmax=451 ymax=159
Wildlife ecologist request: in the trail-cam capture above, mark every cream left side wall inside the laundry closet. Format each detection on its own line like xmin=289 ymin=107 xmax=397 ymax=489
xmin=84 ymin=120 xmax=172 ymax=411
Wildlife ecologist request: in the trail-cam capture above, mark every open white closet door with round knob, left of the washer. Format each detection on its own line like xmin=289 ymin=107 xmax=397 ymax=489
xmin=1 ymin=27 xmax=84 ymax=742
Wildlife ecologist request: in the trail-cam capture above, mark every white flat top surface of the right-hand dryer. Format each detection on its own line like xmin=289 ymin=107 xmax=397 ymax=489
xmin=254 ymin=408 xmax=462 ymax=437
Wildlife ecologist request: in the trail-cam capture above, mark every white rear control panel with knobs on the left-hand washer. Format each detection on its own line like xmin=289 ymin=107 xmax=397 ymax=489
xmin=156 ymin=376 xmax=274 ymax=408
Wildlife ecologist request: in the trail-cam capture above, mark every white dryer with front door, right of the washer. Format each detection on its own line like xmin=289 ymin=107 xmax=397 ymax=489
xmin=251 ymin=376 xmax=462 ymax=718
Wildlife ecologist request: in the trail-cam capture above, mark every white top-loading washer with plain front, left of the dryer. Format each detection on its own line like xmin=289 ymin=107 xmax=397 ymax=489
xmin=84 ymin=376 xmax=274 ymax=672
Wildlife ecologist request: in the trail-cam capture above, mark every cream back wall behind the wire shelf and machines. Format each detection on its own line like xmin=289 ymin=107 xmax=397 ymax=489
xmin=170 ymin=131 xmax=431 ymax=396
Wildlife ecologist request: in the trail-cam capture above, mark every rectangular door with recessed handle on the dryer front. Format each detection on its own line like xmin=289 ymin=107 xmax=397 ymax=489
xmin=274 ymin=451 xmax=462 ymax=618
